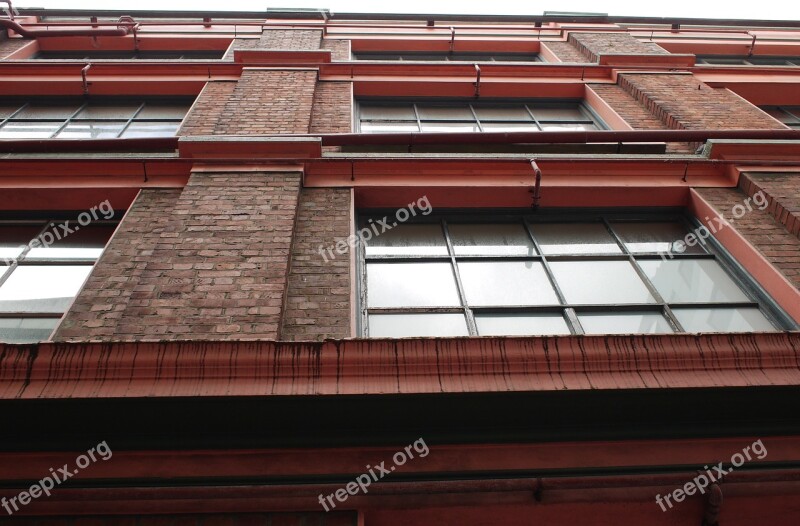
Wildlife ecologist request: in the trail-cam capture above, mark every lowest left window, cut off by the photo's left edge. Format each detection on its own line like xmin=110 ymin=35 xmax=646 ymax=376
xmin=0 ymin=217 xmax=116 ymax=343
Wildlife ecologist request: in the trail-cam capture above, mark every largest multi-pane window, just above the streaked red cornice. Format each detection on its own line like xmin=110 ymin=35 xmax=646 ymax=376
xmin=360 ymin=213 xmax=792 ymax=337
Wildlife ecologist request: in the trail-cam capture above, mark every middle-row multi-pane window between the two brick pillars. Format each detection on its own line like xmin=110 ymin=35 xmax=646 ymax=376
xmin=359 ymin=101 xmax=604 ymax=133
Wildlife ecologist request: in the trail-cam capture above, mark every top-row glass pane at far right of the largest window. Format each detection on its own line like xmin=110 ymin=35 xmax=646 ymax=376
xmin=613 ymin=222 xmax=705 ymax=254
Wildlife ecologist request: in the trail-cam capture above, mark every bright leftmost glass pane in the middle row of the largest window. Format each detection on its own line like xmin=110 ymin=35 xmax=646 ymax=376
xmin=367 ymin=263 xmax=461 ymax=307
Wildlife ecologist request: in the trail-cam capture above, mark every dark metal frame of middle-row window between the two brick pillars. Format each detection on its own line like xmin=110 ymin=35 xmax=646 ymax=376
xmin=353 ymin=97 xmax=611 ymax=135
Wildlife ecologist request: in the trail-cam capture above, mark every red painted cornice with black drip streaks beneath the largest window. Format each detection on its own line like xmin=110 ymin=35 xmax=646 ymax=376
xmin=0 ymin=333 xmax=800 ymax=399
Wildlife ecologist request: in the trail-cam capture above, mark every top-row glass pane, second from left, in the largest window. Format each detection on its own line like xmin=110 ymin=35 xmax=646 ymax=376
xmin=447 ymin=224 xmax=536 ymax=256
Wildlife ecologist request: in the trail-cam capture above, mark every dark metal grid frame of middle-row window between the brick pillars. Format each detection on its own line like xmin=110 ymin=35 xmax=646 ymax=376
xmin=354 ymin=97 xmax=609 ymax=133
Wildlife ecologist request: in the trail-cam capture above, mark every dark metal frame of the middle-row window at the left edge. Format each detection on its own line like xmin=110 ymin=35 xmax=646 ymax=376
xmin=0 ymin=97 xmax=192 ymax=140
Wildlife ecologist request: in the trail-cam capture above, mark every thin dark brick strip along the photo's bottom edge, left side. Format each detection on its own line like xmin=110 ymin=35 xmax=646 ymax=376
xmin=0 ymin=511 xmax=358 ymax=526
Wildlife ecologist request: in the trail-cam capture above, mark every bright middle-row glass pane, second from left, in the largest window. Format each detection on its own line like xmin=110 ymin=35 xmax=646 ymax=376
xmin=458 ymin=261 xmax=559 ymax=306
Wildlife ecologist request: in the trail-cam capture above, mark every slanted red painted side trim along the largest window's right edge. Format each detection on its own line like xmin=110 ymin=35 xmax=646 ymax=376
xmin=689 ymin=190 xmax=800 ymax=323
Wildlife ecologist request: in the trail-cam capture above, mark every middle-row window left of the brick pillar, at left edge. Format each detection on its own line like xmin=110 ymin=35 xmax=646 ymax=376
xmin=0 ymin=99 xmax=191 ymax=139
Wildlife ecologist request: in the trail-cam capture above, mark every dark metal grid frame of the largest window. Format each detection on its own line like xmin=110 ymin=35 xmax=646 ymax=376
xmin=356 ymin=209 xmax=798 ymax=338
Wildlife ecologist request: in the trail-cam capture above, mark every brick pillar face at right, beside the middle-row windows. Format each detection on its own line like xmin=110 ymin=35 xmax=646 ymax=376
xmin=619 ymin=73 xmax=785 ymax=130
